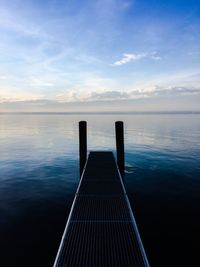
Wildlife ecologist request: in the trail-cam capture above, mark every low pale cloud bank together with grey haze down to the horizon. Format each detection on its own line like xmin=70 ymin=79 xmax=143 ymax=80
xmin=0 ymin=85 xmax=200 ymax=112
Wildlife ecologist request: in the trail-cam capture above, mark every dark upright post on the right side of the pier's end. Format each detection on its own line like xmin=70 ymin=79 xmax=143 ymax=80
xmin=115 ymin=121 xmax=124 ymax=178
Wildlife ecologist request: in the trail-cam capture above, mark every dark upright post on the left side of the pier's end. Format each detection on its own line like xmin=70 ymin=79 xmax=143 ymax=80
xmin=79 ymin=121 xmax=87 ymax=177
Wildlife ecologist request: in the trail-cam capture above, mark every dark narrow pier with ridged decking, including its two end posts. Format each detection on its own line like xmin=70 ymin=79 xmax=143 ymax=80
xmin=54 ymin=122 xmax=149 ymax=267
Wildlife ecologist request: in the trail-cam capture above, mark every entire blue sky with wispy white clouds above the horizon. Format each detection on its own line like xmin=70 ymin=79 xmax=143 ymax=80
xmin=0 ymin=0 xmax=200 ymax=112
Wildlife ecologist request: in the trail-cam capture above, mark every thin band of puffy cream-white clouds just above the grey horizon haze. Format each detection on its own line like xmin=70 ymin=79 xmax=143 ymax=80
xmin=0 ymin=85 xmax=200 ymax=104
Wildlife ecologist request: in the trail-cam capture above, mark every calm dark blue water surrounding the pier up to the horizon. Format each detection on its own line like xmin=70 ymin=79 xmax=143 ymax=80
xmin=0 ymin=114 xmax=200 ymax=267
